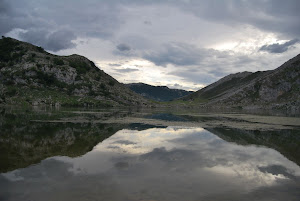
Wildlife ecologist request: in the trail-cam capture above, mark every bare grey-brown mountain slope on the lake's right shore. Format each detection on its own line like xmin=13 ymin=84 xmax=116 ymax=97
xmin=181 ymin=55 xmax=300 ymax=110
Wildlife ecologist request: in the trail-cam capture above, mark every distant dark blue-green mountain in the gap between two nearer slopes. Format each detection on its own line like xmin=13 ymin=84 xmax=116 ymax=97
xmin=126 ymin=83 xmax=192 ymax=101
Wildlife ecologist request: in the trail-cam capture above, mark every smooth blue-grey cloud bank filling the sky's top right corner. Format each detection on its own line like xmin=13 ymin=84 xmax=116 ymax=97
xmin=177 ymin=0 xmax=300 ymax=37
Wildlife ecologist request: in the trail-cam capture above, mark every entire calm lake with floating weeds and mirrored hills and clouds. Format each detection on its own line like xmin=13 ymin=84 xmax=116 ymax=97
xmin=0 ymin=108 xmax=300 ymax=201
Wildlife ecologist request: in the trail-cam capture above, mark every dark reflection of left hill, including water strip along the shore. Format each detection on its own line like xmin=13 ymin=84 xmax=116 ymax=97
xmin=0 ymin=108 xmax=165 ymax=173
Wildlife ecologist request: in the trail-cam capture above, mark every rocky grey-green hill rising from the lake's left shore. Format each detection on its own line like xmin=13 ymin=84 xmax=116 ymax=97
xmin=0 ymin=37 xmax=149 ymax=106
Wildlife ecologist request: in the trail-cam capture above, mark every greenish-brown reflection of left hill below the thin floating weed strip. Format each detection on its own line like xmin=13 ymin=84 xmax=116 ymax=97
xmin=0 ymin=113 xmax=125 ymax=173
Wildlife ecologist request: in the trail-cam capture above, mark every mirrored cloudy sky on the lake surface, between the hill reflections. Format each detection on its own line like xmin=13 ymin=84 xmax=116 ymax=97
xmin=0 ymin=127 xmax=300 ymax=201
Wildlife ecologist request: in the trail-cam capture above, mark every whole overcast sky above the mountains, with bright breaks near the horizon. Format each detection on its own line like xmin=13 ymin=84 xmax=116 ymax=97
xmin=0 ymin=0 xmax=300 ymax=90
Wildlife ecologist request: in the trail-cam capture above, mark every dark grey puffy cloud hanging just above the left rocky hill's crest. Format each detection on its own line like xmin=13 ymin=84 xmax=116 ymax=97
xmin=20 ymin=30 xmax=76 ymax=52
